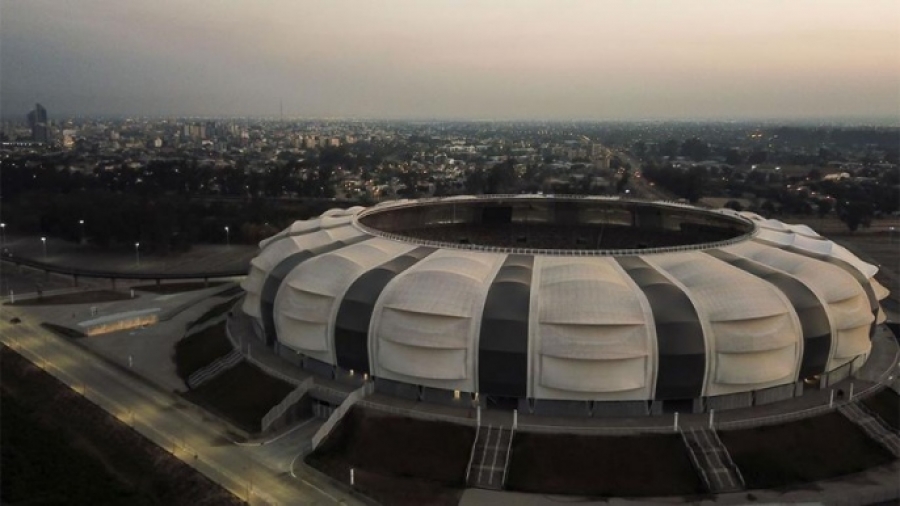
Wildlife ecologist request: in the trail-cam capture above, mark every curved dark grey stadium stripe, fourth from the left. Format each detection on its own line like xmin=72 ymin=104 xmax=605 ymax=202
xmin=616 ymin=257 xmax=706 ymax=400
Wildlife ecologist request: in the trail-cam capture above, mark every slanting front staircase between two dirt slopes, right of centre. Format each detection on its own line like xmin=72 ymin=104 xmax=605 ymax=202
xmin=679 ymin=427 xmax=744 ymax=493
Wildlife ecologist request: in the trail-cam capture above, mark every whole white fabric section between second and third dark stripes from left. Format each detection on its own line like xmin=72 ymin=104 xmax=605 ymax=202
xmin=369 ymin=250 xmax=506 ymax=392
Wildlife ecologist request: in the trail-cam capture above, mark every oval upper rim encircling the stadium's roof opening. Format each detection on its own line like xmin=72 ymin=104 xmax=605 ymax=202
xmin=350 ymin=194 xmax=759 ymax=257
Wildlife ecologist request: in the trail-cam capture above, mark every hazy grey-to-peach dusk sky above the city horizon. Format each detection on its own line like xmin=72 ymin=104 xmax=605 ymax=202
xmin=0 ymin=0 xmax=900 ymax=120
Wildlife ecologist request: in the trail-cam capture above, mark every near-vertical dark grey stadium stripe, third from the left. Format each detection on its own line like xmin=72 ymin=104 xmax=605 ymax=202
xmin=478 ymin=255 xmax=534 ymax=397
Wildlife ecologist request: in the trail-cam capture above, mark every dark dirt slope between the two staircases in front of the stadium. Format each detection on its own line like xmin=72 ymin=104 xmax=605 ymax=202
xmin=506 ymin=432 xmax=705 ymax=498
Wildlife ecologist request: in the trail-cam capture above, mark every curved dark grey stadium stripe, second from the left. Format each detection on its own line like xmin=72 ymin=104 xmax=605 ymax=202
xmin=334 ymin=247 xmax=435 ymax=373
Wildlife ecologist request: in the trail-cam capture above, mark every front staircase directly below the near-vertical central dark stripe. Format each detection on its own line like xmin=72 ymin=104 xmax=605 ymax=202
xmin=467 ymin=425 xmax=513 ymax=490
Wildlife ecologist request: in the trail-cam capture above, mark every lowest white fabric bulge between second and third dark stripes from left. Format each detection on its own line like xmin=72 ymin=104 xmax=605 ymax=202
xmin=378 ymin=341 xmax=469 ymax=383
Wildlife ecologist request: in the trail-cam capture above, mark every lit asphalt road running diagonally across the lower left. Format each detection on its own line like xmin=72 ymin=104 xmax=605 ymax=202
xmin=0 ymin=306 xmax=361 ymax=505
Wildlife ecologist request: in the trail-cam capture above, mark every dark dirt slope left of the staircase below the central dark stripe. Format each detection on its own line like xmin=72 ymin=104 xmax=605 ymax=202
xmin=306 ymin=408 xmax=475 ymax=505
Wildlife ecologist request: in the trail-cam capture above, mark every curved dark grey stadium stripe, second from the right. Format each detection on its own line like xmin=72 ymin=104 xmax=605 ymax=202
xmin=706 ymin=250 xmax=831 ymax=379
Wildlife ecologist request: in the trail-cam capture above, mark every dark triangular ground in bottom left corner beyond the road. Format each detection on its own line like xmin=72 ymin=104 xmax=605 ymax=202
xmin=0 ymin=347 xmax=242 ymax=506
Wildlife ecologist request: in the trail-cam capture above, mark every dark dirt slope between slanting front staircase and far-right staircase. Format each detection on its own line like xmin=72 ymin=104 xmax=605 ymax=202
xmin=719 ymin=412 xmax=894 ymax=489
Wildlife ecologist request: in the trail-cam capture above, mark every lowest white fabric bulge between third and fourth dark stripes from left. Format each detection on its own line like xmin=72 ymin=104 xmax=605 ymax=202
xmin=541 ymin=355 xmax=648 ymax=392
